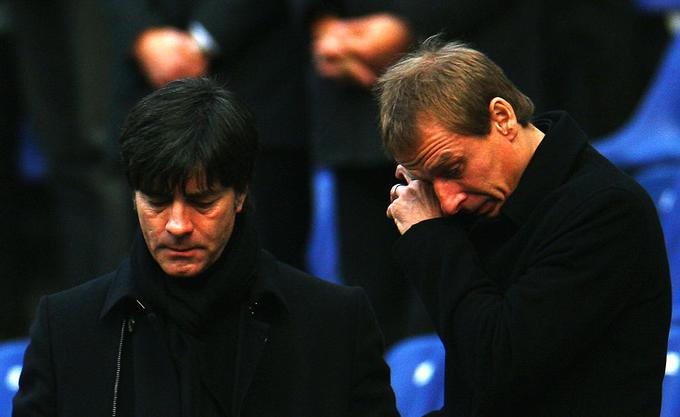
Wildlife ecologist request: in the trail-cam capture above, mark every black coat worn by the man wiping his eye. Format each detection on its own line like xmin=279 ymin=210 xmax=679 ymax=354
xmin=396 ymin=113 xmax=671 ymax=417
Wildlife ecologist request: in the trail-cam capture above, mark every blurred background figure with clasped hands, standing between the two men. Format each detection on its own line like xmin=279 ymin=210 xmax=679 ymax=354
xmin=304 ymin=1 xmax=430 ymax=345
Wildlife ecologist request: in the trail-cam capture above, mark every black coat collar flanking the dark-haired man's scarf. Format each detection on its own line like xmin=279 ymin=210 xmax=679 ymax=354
xmin=99 ymin=250 xmax=288 ymax=319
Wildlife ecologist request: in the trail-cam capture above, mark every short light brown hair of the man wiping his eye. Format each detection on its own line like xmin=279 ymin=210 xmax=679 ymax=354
xmin=376 ymin=36 xmax=534 ymax=156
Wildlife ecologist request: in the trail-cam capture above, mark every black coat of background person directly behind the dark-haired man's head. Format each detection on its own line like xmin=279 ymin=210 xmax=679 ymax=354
xmin=104 ymin=0 xmax=307 ymax=149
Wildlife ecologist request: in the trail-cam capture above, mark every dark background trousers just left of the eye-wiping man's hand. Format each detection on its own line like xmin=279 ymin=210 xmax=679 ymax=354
xmin=335 ymin=166 xmax=433 ymax=346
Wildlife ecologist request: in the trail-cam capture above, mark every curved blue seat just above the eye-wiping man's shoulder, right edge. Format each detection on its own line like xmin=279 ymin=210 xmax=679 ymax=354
xmin=595 ymin=33 xmax=680 ymax=169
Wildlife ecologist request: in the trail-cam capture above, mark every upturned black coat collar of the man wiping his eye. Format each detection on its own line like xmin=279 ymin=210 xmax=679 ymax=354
xmin=501 ymin=111 xmax=587 ymax=226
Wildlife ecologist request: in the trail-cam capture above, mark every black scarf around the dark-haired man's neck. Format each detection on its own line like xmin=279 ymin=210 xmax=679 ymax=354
xmin=131 ymin=213 xmax=259 ymax=417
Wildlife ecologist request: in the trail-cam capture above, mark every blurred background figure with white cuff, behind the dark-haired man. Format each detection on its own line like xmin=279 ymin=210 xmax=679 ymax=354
xmin=102 ymin=0 xmax=310 ymax=267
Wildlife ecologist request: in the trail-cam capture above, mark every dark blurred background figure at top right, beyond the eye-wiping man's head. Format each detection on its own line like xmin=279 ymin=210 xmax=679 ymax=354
xmin=540 ymin=0 xmax=669 ymax=139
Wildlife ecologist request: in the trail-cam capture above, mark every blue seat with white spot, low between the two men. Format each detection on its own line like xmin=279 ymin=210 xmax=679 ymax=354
xmin=385 ymin=335 xmax=445 ymax=417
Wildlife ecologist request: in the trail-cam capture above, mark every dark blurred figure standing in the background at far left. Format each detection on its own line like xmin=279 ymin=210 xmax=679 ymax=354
xmin=10 ymin=0 xmax=132 ymax=332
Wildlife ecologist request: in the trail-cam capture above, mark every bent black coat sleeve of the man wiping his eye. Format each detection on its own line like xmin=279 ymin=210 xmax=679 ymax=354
xmin=395 ymin=189 xmax=658 ymax=406
